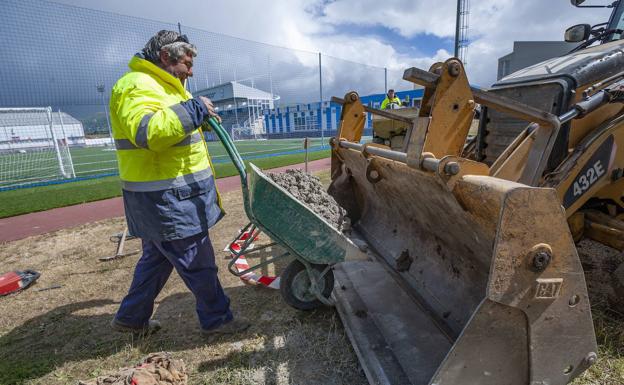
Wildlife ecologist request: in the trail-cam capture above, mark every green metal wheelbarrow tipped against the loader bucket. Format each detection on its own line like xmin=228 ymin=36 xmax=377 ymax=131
xmin=208 ymin=118 xmax=351 ymax=310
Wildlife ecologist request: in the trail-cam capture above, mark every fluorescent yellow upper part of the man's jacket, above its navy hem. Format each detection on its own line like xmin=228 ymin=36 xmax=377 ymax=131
xmin=110 ymin=56 xmax=212 ymax=191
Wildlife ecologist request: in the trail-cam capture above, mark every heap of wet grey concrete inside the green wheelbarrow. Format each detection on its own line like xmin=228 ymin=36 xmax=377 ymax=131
xmin=268 ymin=170 xmax=346 ymax=230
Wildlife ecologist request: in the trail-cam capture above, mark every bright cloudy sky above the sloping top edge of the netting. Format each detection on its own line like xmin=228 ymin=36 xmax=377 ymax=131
xmin=58 ymin=0 xmax=610 ymax=86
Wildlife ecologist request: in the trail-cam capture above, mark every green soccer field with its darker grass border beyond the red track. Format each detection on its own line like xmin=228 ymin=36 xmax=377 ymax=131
xmin=0 ymin=138 xmax=329 ymax=218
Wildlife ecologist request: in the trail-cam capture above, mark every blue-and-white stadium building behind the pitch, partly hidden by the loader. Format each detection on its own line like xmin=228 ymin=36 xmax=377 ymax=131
xmin=264 ymin=88 xmax=424 ymax=138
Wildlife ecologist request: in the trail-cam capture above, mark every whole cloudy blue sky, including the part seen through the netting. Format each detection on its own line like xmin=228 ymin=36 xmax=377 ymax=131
xmin=0 ymin=0 xmax=610 ymax=111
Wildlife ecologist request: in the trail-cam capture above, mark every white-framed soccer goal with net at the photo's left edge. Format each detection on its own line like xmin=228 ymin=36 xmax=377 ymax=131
xmin=0 ymin=107 xmax=76 ymax=191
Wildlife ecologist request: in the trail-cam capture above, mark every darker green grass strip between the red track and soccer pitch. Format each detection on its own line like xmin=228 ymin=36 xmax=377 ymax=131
xmin=0 ymin=150 xmax=330 ymax=218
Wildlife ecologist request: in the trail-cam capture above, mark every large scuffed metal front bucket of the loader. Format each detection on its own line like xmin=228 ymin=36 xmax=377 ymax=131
xmin=330 ymin=146 xmax=596 ymax=385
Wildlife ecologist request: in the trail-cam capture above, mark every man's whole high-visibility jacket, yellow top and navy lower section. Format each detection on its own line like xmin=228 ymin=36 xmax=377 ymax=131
xmin=110 ymin=56 xmax=225 ymax=241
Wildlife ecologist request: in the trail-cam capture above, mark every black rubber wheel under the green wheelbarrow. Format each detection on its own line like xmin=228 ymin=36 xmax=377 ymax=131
xmin=280 ymin=259 xmax=334 ymax=310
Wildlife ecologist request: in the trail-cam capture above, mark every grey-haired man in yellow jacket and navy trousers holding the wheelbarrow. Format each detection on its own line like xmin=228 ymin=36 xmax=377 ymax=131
xmin=110 ymin=30 xmax=249 ymax=334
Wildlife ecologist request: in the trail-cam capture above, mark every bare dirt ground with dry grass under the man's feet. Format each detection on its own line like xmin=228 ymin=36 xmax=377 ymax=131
xmin=0 ymin=171 xmax=367 ymax=385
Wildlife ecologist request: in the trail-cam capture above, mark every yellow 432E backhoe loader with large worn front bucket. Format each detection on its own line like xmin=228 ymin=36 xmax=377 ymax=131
xmin=329 ymin=0 xmax=624 ymax=385
